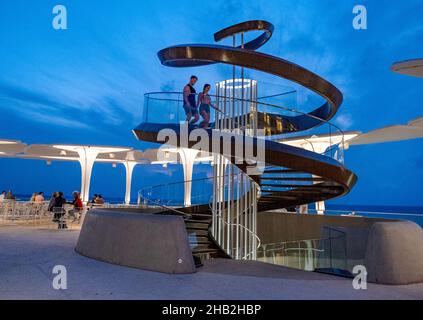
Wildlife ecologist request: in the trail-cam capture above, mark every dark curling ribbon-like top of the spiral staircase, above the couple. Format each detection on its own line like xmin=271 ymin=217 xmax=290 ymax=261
xmin=158 ymin=20 xmax=343 ymax=131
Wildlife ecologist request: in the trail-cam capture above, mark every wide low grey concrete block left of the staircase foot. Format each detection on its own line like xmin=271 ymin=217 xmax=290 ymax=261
xmin=75 ymin=209 xmax=195 ymax=274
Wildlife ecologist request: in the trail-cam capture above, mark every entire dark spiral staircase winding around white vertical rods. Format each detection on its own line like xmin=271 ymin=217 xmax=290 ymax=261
xmin=133 ymin=20 xmax=357 ymax=265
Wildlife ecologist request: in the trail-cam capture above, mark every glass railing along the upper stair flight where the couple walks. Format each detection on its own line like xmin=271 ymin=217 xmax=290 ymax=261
xmin=142 ymin=91 xmax=345 ymax=162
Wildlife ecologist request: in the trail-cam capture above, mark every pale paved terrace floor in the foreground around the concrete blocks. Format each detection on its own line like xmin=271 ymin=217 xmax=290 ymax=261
xmin=0 ymin=227 xmax=423 ymax=300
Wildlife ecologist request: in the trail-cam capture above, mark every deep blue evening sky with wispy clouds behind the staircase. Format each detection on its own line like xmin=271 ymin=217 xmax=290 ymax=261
xmin=0 ymin=0 xmax=423 ymax=206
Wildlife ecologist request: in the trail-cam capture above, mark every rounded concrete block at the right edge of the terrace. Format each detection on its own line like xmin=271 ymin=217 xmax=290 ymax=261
xmin=364 ymin=222 xmax=423 ymax=285
